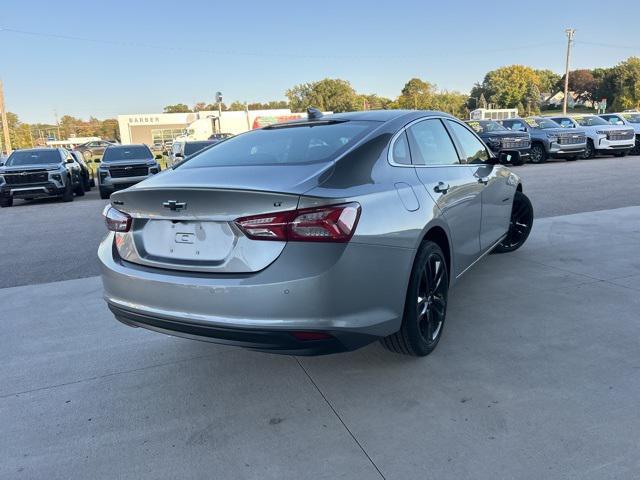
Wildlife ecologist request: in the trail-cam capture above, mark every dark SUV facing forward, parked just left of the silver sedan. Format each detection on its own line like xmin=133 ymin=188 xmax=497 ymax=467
xmin=98 ymin=145 xmax=161 ymax=200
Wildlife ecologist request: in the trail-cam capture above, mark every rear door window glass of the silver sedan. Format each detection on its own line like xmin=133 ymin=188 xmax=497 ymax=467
xmin=407 ymin=119 xmax=460 ymax=165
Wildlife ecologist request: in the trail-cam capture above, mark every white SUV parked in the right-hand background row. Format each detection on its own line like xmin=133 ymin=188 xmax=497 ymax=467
xmin=551 ymin=115 xmax=635 ymax=158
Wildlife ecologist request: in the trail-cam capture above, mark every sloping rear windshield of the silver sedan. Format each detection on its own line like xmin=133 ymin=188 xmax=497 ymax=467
xmin=183 ymin=121 xmax=380 ymax=168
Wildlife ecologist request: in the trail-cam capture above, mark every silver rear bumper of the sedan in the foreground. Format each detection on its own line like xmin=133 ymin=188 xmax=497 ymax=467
xmin=98 ymin=235 xmax=415 ymax=355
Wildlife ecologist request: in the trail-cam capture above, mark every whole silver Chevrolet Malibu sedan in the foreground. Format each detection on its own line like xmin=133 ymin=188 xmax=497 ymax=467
xmin=98 ymin=109 xmax=533 ymax=356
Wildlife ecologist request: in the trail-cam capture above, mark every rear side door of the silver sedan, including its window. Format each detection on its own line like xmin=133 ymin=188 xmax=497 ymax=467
xmin=407 ymin=118 xmax=484 ymax=276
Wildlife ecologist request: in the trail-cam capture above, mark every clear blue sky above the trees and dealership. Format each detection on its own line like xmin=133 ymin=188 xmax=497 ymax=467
xmin=0 ymin=0 xmax=640 ymax=122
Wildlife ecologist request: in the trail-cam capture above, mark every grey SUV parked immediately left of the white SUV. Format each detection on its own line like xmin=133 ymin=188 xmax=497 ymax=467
xmin=501 ymin=117 xmax=587 ymax=163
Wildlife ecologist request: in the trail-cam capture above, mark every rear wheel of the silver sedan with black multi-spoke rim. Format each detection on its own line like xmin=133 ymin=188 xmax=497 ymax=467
xmin=380 ymin=241 xmax=449 ymax=357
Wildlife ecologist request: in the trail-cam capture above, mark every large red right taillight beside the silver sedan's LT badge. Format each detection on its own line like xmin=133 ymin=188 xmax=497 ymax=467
xmin=236 ymin=202 xmax=360 ymax=242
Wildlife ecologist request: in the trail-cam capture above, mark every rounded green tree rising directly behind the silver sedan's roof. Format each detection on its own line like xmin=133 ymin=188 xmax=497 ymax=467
xmin=285 ymin=78 xmax=358 ymax=112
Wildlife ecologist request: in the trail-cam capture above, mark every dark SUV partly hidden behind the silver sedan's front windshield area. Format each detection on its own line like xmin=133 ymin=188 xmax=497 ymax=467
xmin=466 ymin=120 xmax=531 ymax=165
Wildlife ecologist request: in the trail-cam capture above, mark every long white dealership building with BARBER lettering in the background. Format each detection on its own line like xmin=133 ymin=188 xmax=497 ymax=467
xmin=118 ymin=109 xmax=304 ymax=145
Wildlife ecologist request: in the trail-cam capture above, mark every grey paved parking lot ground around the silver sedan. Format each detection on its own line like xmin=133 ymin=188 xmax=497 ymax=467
xmin=0 ymin=157 xmax=640 ymax=480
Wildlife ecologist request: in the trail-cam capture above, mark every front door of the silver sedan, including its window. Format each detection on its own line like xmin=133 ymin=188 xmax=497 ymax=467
xmin=445 ymin=119 xmax=515 ymax=252
